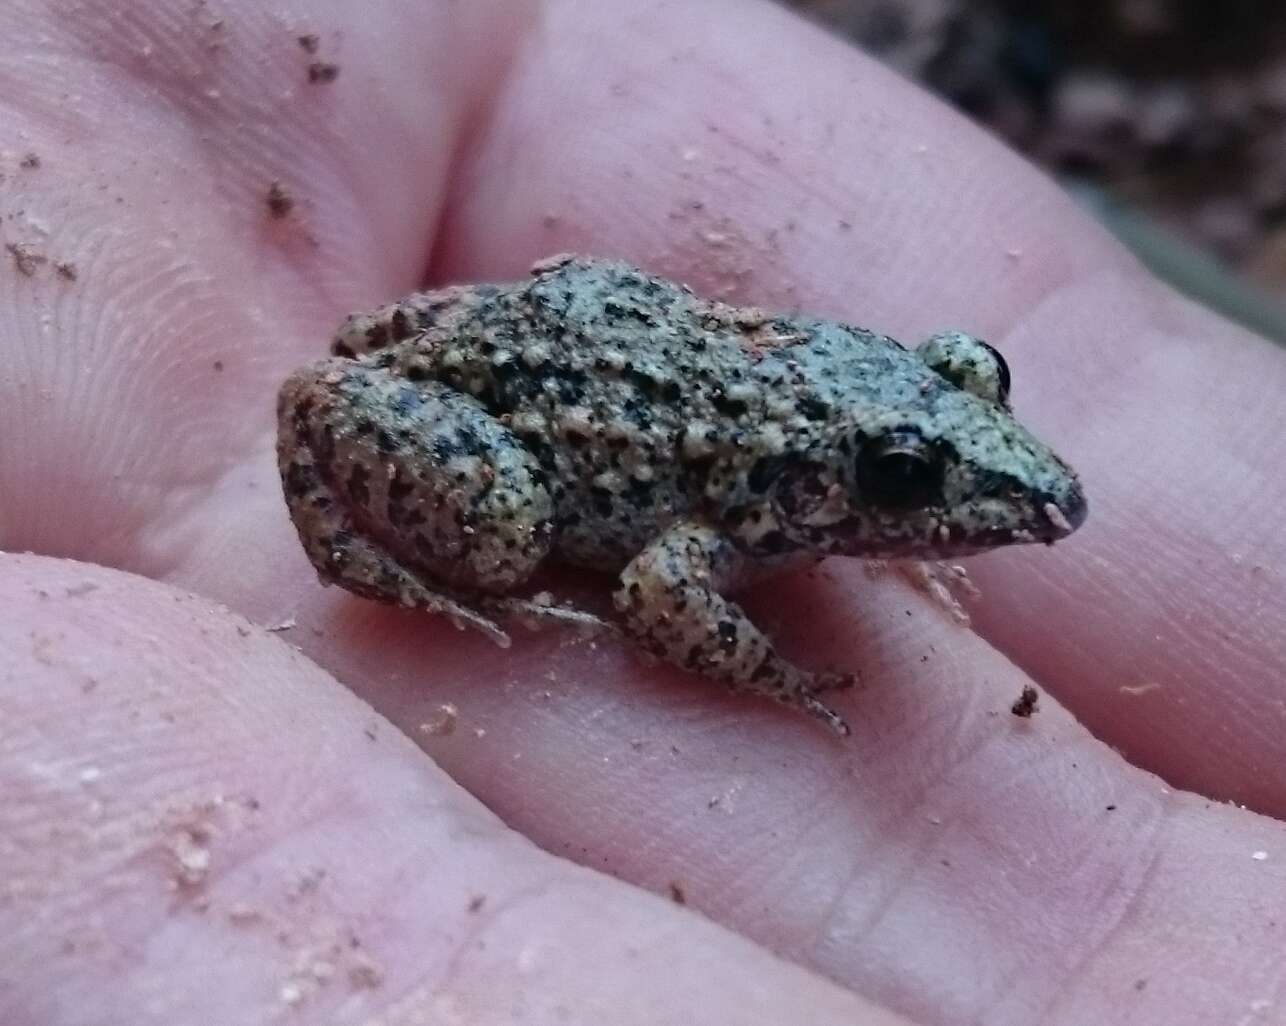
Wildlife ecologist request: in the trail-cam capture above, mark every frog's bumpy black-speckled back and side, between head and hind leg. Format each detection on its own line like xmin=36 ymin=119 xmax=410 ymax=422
xmin=399 ymin=260 xmax=907 ymax=570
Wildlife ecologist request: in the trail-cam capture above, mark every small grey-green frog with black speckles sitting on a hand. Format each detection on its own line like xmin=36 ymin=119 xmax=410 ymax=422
xmin=278 ymin=256 xmax=1087 ymax=734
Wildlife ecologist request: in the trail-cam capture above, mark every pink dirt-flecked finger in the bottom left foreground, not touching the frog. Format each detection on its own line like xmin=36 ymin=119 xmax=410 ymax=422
xmin=0 ymin=557 xmax=903 ymax=1026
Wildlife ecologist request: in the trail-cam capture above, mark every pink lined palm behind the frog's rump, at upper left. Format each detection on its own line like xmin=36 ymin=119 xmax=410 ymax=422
xmin=0 ymin=0 xmax=529 ymax=570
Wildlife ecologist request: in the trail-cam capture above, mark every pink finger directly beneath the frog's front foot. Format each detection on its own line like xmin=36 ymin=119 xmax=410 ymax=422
xmin=311 ymin=555 xmax=1286 ymax=1026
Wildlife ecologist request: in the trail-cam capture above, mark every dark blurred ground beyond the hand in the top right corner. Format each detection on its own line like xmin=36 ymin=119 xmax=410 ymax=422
xmin=786 ymin=0 xmax=1286 ymax=341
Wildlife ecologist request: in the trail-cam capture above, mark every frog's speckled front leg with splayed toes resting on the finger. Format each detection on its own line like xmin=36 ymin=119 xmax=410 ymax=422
xmin=615 ymin=521 xmax=853 ymax=735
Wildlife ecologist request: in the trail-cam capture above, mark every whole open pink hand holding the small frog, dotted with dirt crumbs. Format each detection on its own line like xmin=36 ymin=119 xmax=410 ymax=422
xmin=0 ymin=0 xmax=1286 ymax=1023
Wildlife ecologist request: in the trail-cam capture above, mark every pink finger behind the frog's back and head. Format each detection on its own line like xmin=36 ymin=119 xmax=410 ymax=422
xmin=421 ymin=0 xmax=1286 ymax=814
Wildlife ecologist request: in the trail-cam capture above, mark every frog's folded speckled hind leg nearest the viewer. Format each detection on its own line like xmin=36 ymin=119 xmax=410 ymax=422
xmin=278 ymin=359 xmax=553 ymax=644
